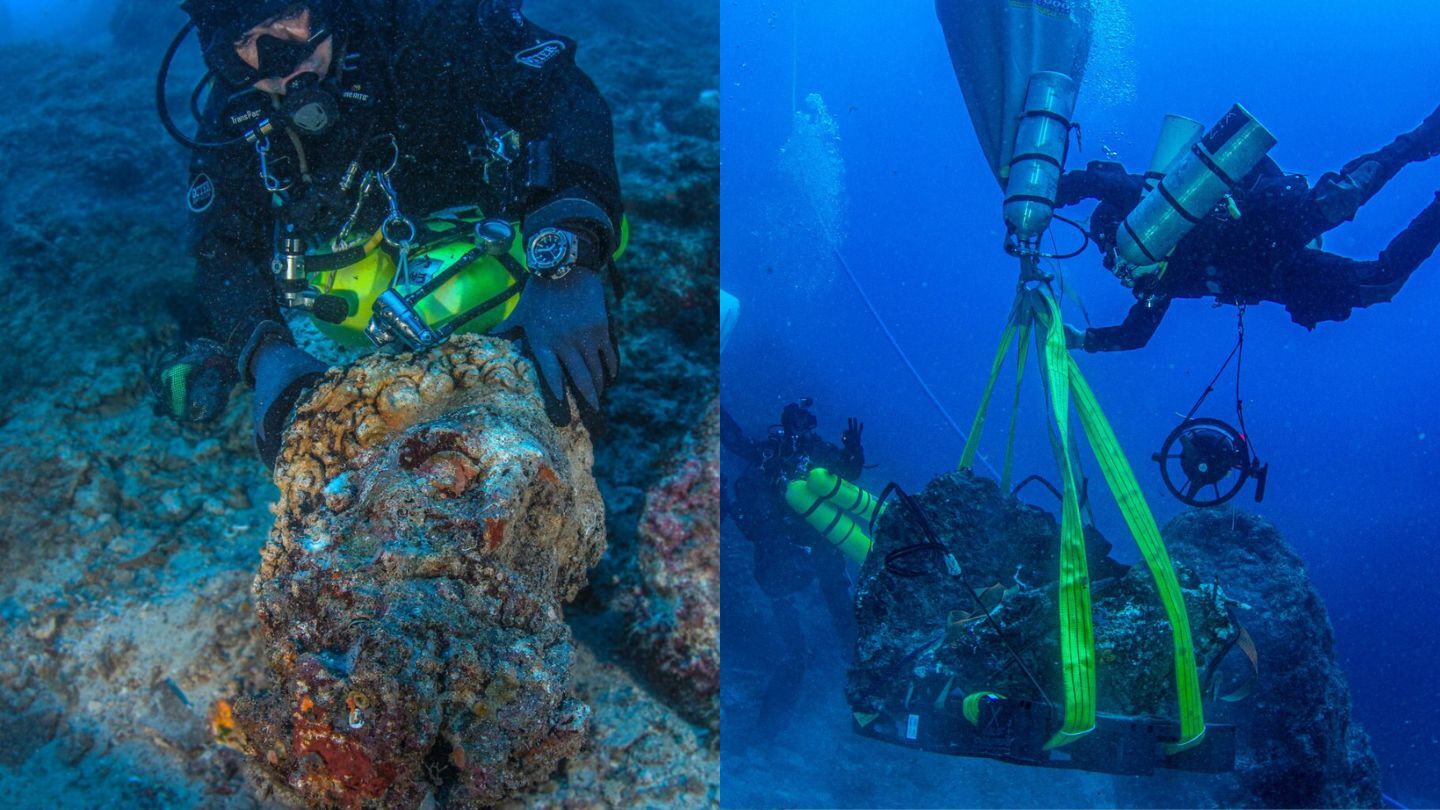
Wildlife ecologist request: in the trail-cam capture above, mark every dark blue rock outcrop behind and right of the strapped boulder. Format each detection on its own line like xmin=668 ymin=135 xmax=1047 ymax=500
xmin=1119 ymin=509 xmax=1385 ymax=807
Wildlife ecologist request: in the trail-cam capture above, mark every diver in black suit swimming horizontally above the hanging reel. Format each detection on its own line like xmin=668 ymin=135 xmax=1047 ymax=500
xmin=1058 ymin=103 xmax=1440 ymax=352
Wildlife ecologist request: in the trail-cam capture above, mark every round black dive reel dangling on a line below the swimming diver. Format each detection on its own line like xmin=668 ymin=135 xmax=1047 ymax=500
xmin=1151 ymin=304 xmax=1270 ymax=507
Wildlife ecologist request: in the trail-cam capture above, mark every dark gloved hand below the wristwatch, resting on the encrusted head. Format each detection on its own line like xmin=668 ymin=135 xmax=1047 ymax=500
xmin=492 ymin=267 xmax=621 ymax=427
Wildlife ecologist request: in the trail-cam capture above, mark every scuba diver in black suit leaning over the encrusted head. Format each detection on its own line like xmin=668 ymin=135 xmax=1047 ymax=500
xmin=151 ymin=0 xmax=622 ymax=466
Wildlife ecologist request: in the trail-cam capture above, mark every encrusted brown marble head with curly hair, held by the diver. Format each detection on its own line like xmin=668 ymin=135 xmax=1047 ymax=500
xmin=236 ymin=337 xmax=605 ymax=807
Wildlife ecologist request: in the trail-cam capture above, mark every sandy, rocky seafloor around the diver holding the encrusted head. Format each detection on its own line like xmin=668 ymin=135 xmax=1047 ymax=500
xmin=0 ymin=0 xmax=719 ymax=807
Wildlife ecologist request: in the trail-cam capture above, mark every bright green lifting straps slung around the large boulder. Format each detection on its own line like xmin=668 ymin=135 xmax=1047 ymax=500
xmin=959 ymin=287 xmax=1205 ymax=754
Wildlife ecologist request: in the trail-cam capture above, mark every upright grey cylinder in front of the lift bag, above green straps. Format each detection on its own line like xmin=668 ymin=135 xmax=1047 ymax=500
xmin=1005 ymin=71 xmax=1076 ymax=241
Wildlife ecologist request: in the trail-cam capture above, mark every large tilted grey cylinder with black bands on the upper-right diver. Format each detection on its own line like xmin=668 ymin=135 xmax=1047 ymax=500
xmin=1116 ymin=104 xmax=1274 ymax=267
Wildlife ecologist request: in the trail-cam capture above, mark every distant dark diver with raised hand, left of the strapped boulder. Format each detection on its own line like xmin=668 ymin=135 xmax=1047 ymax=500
xmin=720 ymin=399 xmax=865 ymax=722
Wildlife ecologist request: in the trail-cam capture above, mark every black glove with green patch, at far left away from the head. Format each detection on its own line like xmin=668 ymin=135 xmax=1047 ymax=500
xmin=147 ymin=337 xmax=239 ymax=424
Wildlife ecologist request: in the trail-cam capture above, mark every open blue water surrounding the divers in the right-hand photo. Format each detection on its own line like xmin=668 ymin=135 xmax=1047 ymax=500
xmin=721 ymin=0 xmax=1440 ymax=806
